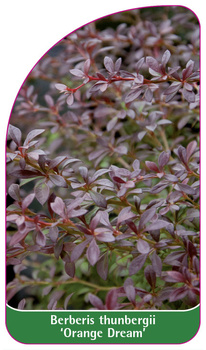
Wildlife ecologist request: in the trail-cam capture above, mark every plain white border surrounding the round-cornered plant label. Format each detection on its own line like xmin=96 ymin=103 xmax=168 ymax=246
xmin=0 ymin=0 xmax=206 ymax=350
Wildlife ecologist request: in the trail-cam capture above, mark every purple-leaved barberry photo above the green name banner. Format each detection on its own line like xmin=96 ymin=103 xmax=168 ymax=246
xmin=6 ymin=6 xmax=200 ymax=310
